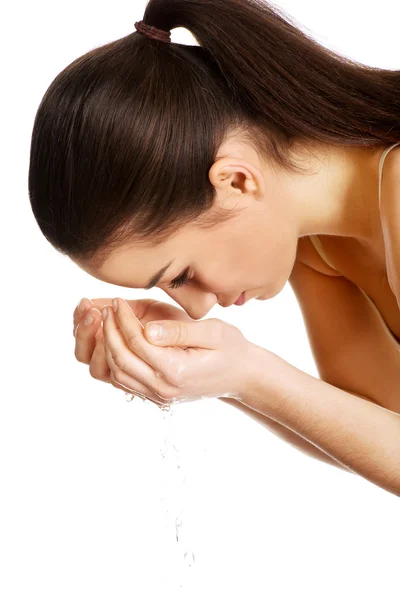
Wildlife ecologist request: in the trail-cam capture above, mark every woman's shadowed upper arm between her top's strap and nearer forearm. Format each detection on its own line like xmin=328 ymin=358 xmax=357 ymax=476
xmin=289 ymin=255 xmax=400 ymax=413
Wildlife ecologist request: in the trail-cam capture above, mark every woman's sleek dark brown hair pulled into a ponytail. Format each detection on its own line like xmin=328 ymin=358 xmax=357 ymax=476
xmin=28 ymin=0 xmax=400 ymax=266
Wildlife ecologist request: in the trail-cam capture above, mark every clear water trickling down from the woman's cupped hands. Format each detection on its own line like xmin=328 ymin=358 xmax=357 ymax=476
xmin=126 ymin=394 xmax=195 ymax=598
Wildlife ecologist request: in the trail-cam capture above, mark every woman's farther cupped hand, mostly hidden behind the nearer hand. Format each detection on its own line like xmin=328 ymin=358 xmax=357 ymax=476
xmin=73 ymin=298 xmax=197 ymax=402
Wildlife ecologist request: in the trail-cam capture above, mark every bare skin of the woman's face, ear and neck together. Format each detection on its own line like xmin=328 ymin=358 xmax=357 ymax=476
xmin=76 ymin=137 xmax=388 ymax=319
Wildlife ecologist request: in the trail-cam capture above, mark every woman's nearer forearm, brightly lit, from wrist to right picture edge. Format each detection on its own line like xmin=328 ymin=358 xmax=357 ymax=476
xmin=241 ymin=346 xmax=400 ymax=496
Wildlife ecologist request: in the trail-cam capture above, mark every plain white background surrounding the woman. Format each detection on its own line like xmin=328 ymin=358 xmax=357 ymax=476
xmin=0 ymin=0 xmax=400 ymax=600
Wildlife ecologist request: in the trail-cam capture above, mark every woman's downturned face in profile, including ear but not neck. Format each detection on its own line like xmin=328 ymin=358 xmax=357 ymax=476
xmin=79 ymin=144 xmax=298 ymax=319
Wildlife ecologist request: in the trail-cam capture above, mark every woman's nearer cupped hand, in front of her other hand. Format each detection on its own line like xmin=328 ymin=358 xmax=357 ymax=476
xmin=99 ymin=298 xmax=258 ymax=404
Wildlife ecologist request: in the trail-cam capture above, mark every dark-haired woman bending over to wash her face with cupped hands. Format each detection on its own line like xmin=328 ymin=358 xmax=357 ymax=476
xmin=29 ymin=0 xmax=400 ymax=495
